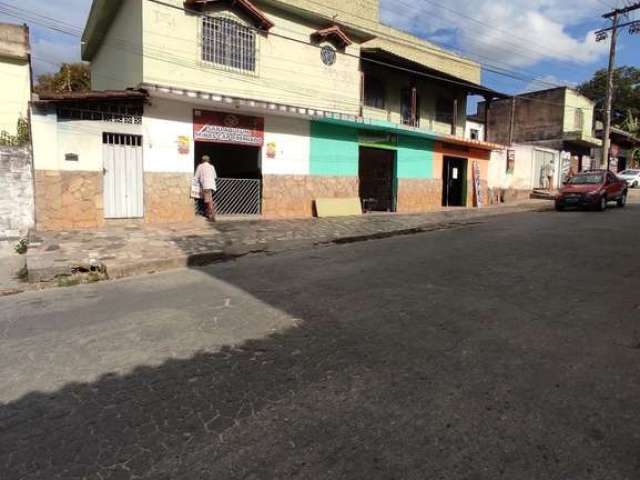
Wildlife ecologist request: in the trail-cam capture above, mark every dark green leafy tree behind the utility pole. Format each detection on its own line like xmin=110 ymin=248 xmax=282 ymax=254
xmin=578 ymin=67 xmax=640 ymax=128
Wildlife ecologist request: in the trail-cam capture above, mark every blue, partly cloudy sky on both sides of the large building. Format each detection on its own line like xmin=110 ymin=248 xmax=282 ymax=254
xmin=0 ymin=0 xmax=640 ymax=98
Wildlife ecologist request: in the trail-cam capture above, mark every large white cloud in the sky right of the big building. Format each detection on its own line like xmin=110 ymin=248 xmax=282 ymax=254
xmin=382 ymin=0 xmax=607 ymax=68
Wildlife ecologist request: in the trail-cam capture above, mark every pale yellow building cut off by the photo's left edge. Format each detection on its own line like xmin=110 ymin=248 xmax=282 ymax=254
xmin=0 ymin=23 xmax=31 ymax=135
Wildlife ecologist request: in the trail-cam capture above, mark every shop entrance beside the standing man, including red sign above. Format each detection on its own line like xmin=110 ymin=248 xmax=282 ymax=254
xmin=193 ymin=110 xmax=264 ymax=215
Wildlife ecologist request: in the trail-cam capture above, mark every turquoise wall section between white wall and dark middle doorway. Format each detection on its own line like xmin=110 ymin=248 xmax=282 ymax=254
xmin=310 ymin=122 xmax=359 ymax=177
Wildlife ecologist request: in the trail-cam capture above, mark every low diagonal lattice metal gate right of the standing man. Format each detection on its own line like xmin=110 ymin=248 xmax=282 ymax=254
xmin=214 ymin=178 xmax=262 ymax=215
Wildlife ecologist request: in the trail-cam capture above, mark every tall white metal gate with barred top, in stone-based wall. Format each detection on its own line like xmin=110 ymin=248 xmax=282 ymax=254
xmin=102 ymin=133 xmax=144 ymax=218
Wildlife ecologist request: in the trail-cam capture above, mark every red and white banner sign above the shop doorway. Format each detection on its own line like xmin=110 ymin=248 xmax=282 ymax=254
xmin=193 ymin=110 xmax=264 ymax=147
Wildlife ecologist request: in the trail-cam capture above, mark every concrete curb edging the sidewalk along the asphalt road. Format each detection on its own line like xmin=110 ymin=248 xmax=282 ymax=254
xmin=28 ymin=204 xmax=553 ymax=287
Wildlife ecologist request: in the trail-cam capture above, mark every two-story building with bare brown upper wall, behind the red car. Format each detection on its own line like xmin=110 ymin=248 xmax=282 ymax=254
xmin=471 ymin=87 xmax=602 ymax=200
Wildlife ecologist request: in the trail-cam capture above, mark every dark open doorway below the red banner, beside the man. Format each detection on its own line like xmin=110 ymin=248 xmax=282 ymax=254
xmin=194 ymin=142 xmax=262 ymax=215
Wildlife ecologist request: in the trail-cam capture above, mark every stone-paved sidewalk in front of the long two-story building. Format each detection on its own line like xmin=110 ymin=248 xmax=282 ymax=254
xmin=27 ymin=200 xmax=552 ymax=284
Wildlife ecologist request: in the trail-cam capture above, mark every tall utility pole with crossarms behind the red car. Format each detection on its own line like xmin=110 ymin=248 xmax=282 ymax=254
xmin=596 ymin=2 xmax=640 ymax=170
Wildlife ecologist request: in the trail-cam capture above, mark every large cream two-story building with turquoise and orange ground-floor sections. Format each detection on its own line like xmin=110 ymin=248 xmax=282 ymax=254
xmin=34 ymin=0 xmax=508 ymax=228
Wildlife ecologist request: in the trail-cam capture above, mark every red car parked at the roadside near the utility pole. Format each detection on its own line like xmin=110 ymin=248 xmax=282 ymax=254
xmin=556 ymin=170 xmax=628 ymax=211
